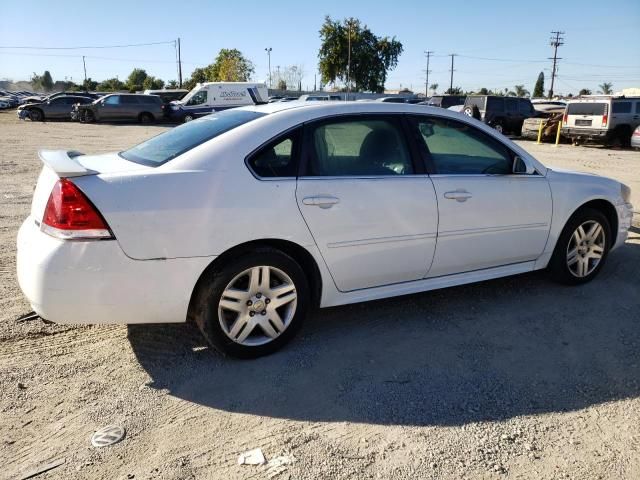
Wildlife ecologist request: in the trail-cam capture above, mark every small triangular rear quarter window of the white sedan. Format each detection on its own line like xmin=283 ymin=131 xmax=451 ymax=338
xmin=247 ymin=128 xmax=301 ymax=178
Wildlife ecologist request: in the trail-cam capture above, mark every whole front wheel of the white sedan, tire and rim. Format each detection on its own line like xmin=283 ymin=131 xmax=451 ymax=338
xmin=549 ymin=208 xmax=612 ymax=285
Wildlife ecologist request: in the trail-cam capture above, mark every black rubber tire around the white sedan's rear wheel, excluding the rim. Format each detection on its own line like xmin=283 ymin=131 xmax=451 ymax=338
xmin=193 ymin=247 xmax=310 ymax=358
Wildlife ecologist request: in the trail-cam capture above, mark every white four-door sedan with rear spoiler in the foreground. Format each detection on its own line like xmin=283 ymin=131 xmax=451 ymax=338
xmin=17 ymin=102 xmax=632 ymax=357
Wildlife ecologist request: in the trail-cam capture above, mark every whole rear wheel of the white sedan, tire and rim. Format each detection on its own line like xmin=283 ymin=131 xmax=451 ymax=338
xmin=192 ymin=247 xmax=309 ymax=358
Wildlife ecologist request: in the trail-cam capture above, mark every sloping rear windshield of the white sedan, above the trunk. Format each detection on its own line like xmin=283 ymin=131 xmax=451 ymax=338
xmin=120 ymin=110 xmax=266 ymax=167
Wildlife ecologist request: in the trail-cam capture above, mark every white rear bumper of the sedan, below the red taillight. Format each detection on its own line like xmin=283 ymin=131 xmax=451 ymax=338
xmin=17 ymin=217 xmax=214 ymax=324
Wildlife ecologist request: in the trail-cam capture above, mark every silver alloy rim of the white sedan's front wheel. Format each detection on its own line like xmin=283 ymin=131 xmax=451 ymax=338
xmin=567 ymin=220 xmax=606 ymax=278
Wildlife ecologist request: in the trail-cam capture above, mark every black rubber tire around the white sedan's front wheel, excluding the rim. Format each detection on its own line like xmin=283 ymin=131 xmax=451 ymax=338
xmin=549 ymin=208 xmax=613 ymax=285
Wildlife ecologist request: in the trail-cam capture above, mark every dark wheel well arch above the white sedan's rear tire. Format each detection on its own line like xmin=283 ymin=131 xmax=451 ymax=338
xmin=187 ymin=238 xmax=322 ymax=320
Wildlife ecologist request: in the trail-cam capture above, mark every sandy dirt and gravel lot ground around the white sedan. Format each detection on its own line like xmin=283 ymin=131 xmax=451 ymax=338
xmin=0 ymin=112 xmax=640 ymax=480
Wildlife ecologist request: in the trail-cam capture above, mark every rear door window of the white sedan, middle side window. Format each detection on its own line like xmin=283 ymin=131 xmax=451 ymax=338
xmin=306 ymin=117 xmax=414 ymax=177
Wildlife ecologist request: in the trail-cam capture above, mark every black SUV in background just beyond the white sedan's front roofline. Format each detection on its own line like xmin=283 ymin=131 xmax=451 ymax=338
xmin=462 ymin=95 xmax=536 ymax=135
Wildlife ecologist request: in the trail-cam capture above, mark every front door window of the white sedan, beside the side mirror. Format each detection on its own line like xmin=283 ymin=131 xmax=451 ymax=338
xmin=417 ymin=117 xmax=513 ymax=175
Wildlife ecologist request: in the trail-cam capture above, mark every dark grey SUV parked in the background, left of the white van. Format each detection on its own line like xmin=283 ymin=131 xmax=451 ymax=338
xmin=72 ymin=93 xmax=165 ymax=123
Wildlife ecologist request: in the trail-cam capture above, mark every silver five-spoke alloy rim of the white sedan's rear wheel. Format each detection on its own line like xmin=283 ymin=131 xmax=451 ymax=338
xmin=218 ymin=266 xmax=298 ymax=347
